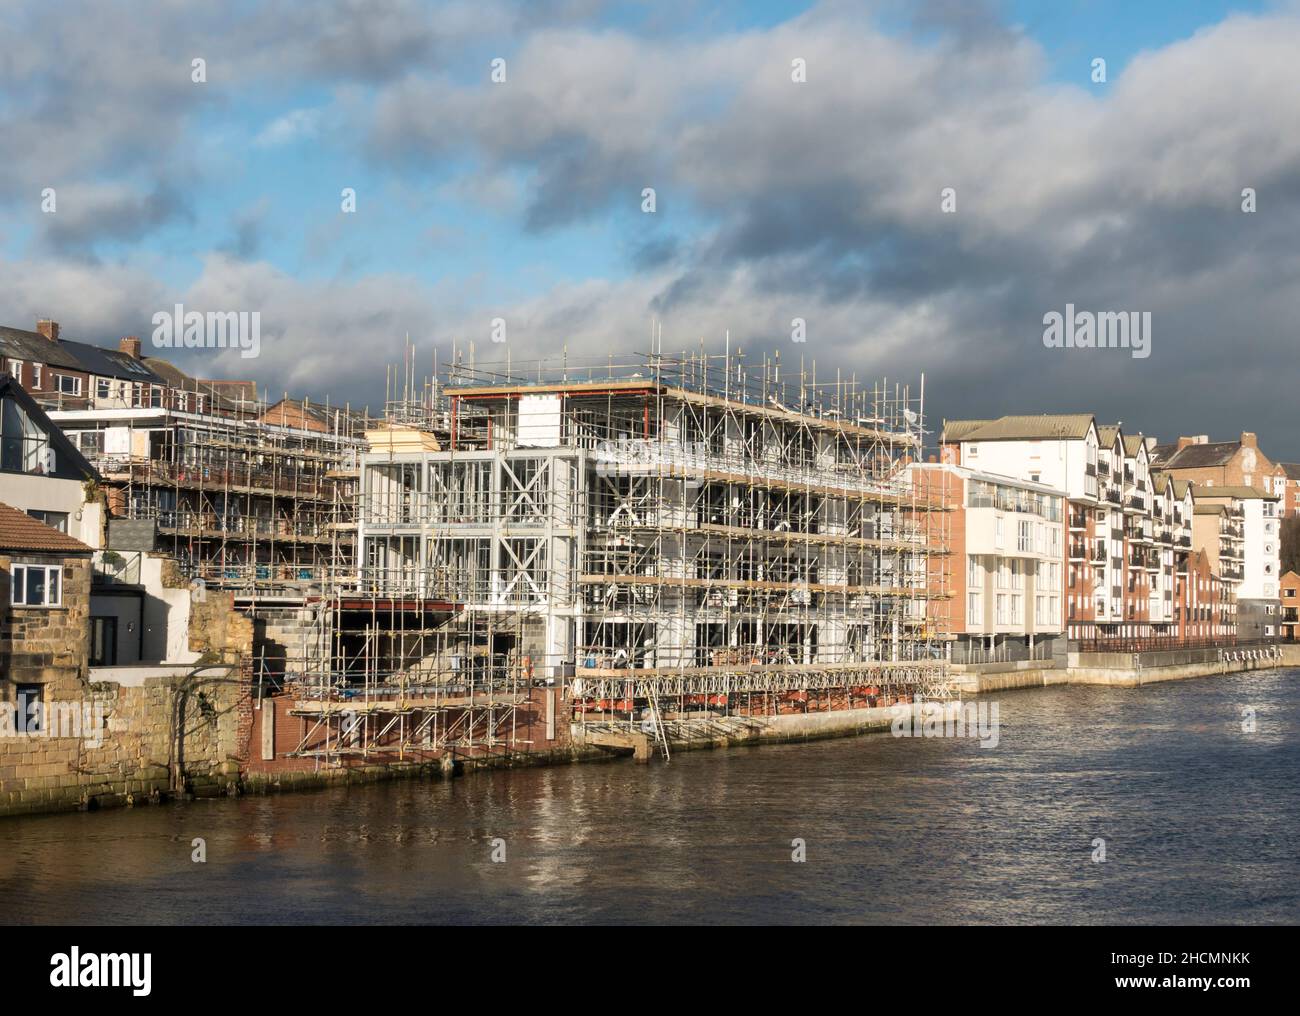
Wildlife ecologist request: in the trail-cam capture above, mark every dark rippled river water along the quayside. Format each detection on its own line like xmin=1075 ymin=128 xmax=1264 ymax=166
xmin=0 ymin=670 xmax=1300 ymax=924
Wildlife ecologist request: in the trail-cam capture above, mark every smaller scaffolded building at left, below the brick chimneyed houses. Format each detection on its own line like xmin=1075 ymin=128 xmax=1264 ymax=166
xmin=52 ymin=378 xmax=372 ymax=600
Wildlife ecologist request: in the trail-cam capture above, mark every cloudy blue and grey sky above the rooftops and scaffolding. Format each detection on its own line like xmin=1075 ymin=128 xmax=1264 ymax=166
xmin=0 ymin=0 xmax=1300 ymax=461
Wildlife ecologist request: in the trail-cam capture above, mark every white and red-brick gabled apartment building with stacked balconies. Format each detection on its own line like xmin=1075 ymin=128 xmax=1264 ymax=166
xmin=943 ymin=413 xmax=1195 ymax=644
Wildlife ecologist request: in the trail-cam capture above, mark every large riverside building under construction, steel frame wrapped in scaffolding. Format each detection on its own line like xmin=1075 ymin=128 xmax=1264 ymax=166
xmin=274 ymin=353 xmax=948 ymax=763
